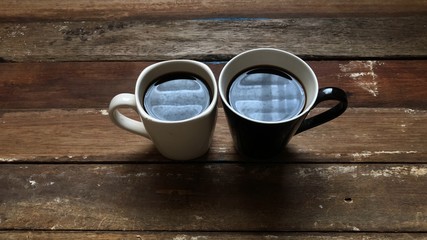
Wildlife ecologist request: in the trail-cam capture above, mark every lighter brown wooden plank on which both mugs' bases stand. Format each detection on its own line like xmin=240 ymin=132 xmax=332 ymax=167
xmin=0 ymin=108 xmax=427 ymax=163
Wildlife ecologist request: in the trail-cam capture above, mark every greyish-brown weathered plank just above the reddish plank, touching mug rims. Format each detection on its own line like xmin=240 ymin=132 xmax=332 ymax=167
xmin=0 ymin=15 xmax=427 ymax=62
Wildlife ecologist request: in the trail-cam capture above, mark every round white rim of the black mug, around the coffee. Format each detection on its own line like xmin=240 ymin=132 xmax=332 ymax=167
xmin=218 ymin=48 xmax=319 ymax=124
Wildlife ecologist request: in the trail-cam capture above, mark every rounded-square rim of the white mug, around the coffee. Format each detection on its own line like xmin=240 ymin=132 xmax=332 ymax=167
xmin=135 ymin=59 xmax=218 ymax=124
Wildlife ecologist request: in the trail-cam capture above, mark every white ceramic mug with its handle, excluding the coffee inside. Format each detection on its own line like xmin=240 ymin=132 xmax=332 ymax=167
xmin=109 ymin=60 xmax=218 ymax=160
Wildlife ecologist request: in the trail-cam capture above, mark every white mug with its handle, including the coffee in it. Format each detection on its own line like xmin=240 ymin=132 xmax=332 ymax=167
xmin=109 ymin=60 xmax=218 ymax=160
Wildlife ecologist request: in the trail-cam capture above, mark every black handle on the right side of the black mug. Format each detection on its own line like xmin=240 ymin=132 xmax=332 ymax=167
xmin=295 ymin=87 xmax=348 ymax=134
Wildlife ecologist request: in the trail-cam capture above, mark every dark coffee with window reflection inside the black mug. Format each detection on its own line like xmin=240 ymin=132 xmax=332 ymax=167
xmin=228 ymin=66 xmax=306 ymax=122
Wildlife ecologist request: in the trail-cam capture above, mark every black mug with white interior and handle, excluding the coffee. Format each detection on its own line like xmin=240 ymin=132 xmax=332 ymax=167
xmin=218 ymin=48 xmax=347 ymax=158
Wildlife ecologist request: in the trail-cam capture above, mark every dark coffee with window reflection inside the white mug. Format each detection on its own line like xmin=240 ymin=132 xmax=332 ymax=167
xmin=144 ymin=73 xmax=211 ymax=121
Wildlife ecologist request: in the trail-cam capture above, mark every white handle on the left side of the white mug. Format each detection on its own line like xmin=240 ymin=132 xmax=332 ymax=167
xmin=108 ymin=93 xmax=151 ymax=139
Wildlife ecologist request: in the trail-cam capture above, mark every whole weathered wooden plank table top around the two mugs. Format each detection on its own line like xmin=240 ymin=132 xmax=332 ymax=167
xmin=0 ymin=0 xmax=427 ymax=240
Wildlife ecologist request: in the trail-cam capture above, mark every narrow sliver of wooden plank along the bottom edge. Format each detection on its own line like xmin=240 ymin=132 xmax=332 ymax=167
xmin=0 ymin=231 xmax=425 ymax=240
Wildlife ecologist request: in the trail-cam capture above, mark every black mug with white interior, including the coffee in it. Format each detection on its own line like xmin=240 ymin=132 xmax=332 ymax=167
xmin=219 ymin=48 xmax=347 ymax=158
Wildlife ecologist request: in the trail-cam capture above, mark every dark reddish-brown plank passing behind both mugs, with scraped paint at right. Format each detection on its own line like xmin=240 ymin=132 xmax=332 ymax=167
xmin=0 ymin=60 xmax=427 ymax=109
